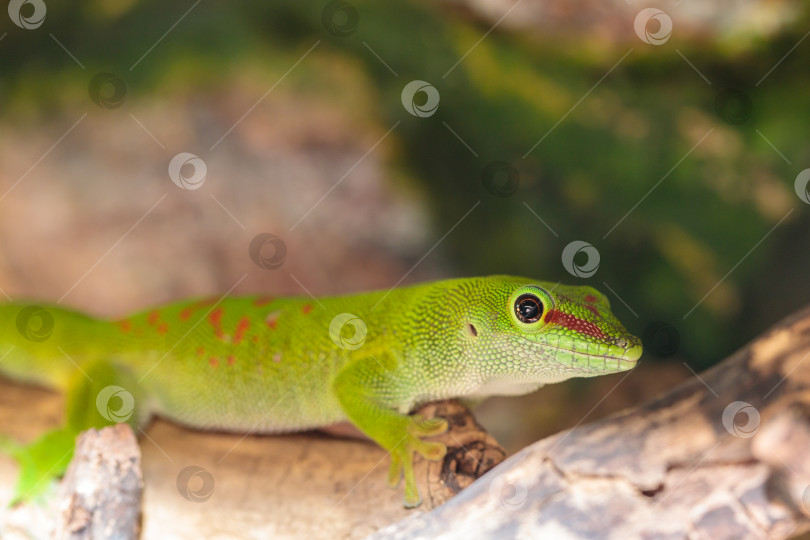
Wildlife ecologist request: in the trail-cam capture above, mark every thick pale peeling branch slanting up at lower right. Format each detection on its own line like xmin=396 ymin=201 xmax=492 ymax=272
xmin=372 ymin=309 xmax=810 ymax=540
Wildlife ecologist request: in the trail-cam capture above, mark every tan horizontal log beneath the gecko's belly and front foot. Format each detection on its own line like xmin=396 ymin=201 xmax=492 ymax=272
xmin=0 ymin=386 xmax=492 ymax=540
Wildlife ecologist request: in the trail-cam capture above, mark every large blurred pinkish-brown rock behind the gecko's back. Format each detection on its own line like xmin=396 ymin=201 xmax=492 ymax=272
xmin=0 ymin=85 xmax=430 ymax=315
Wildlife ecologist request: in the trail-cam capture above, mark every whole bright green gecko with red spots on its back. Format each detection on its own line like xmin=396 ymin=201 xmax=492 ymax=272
xmin=0 ymin=276 xmax=642 ymax=507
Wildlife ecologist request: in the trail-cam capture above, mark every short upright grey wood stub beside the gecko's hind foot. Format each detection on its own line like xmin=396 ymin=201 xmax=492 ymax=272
xmin=55 ymin=424 xmax=143 ymax=540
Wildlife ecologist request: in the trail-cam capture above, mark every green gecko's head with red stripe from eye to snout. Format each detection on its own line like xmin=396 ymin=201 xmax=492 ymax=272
xmin=464 ymin=276 xmax=642 ymax=383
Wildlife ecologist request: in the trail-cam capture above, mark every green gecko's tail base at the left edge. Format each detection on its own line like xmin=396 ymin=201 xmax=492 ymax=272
xmin=0 ymin=301 xmax=109 ymax=389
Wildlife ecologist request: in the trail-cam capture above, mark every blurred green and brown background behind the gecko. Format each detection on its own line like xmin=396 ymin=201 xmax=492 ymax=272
xmin=0 ymin=0 xmax=810 ymax=452
